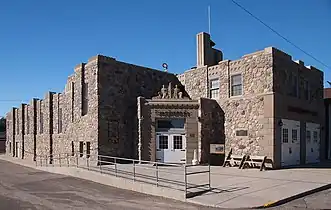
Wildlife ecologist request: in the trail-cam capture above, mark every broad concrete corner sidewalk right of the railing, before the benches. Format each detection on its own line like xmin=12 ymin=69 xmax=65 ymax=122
xmin=189 ymin=167 xmax=331 ymax=208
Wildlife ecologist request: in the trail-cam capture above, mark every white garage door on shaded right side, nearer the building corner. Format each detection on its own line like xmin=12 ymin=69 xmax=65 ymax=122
xmin=281 ymin=119 xmax=300 ymax=166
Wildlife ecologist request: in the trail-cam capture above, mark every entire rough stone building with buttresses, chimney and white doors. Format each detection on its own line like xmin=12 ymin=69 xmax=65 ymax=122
xmin=6 ymin=33 xmax=326 ymax=168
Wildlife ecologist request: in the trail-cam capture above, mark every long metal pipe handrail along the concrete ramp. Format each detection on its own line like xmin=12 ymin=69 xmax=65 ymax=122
xmin=31 ymin=152 xmax=211 ymax=197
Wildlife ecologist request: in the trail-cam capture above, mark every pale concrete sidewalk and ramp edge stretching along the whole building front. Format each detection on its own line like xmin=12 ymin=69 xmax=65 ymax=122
xmin=0 ymin=155 xmax=331 ymax=208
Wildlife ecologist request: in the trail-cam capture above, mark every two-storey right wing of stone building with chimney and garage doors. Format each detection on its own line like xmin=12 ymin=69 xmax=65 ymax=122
xmin=178 ymin=33 xmax=325 ymax=167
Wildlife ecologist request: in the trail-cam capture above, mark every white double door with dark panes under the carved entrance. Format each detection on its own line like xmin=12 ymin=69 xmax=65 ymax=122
xmin=156 ymin=134 xmax=186 ymax=163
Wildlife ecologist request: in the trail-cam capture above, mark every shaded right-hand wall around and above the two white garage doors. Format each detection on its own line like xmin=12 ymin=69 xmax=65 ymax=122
xmin=273 ymin=49 xmax=325 ymax=167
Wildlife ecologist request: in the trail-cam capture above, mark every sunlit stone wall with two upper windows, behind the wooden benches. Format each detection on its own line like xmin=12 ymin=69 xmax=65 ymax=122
xmin=179 ymin=48 xmax=273 ymax=158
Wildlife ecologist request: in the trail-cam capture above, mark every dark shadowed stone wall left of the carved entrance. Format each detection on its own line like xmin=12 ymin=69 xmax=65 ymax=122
xmin=97 ymin=56 xmax=180 ymax=158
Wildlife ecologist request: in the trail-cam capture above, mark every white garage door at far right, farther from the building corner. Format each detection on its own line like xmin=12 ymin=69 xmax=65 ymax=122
xmin=306 ymin=123 xmax=321 ymax=163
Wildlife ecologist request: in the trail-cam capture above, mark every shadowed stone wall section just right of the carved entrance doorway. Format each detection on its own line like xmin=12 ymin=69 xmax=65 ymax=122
xmin=199 ymin=98 xmax=225 ymax=165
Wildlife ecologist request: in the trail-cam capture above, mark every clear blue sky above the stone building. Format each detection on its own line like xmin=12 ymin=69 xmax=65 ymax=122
xmin=0 ymin=0 xmax=331 ymax=116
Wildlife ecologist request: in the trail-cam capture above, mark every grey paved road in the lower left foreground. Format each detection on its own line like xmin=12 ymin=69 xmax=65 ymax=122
xmin=0 ymin=160 xmax=218 ymax=210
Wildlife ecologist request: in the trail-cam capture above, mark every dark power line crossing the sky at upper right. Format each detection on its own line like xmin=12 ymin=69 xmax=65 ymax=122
xmin=231 ymin=0 xmax=331 ymax=70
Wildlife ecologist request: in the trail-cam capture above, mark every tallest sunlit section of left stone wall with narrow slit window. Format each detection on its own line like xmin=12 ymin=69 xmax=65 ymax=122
xmin=59 ymin=59 xmax=98 ymax=159
